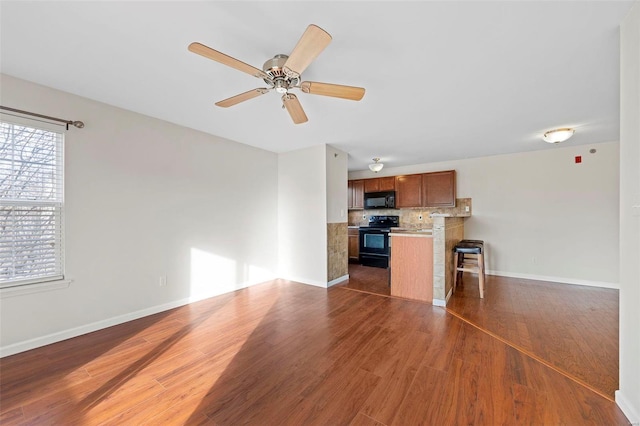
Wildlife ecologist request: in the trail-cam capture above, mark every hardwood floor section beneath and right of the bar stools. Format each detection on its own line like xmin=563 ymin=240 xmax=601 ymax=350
xmin=447 ymin=274 xmax=619 ymax=399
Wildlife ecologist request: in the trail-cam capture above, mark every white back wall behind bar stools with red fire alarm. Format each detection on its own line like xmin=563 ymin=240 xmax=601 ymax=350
xmin=349 ymin=141 xmax=619 ymax=288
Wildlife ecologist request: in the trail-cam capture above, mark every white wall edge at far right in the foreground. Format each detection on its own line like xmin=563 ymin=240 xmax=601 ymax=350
xmin=616 ymin=2 xmax=640 ymax=424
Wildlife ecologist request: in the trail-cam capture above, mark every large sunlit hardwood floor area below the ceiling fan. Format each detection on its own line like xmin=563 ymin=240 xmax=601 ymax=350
xmin=0 ymin=274 xmax=628 ymax=425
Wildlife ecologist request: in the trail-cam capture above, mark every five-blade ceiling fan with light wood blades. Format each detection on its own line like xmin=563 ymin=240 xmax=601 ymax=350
xmin=189 ymin=24 xmax=364 ymax=124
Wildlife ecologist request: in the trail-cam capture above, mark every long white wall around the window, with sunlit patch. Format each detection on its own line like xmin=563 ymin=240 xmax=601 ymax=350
xmin=0 ymin=75 xmax=280 ymax=355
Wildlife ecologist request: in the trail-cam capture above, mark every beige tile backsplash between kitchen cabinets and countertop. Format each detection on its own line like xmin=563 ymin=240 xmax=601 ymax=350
xmin=349 ymin=198 xmax=472 ymax=228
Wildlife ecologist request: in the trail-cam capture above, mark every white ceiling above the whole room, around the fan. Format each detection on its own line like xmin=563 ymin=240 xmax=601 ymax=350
xmin=0 ymin=1 xmax=632 ymax=170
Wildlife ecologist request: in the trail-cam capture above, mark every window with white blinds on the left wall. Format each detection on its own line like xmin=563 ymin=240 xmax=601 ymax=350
xmin=0 ymin=120 xmax=64 ymax=288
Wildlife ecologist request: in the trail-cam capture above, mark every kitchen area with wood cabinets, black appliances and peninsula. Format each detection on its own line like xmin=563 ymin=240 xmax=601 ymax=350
xmin=345 ymin=170 xmax=471 ymax=306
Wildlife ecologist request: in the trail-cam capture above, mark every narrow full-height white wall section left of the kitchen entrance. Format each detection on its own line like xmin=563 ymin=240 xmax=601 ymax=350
xmin=278 ymin=145 xmax=327 ymax=287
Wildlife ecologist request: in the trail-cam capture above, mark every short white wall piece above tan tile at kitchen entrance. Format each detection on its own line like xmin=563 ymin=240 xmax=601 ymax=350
xmin=326 ymin=146 xmax=348 ymax=223
